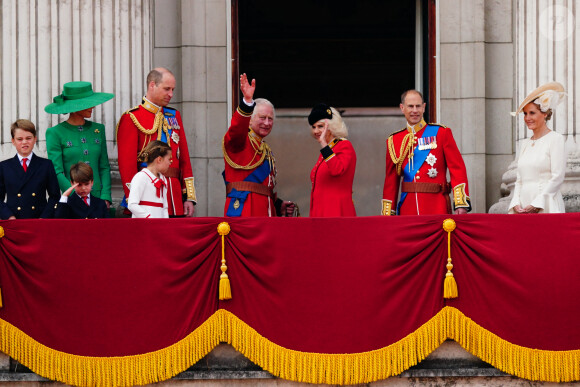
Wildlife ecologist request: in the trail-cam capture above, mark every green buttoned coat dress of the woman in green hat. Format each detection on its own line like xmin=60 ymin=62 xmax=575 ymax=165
xmin=46 ymin=120 xmax=111 ymax=201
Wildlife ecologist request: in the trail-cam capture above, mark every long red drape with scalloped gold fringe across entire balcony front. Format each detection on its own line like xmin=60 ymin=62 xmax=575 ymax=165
xmin=0 ymin=214 xmax=580 ymax=384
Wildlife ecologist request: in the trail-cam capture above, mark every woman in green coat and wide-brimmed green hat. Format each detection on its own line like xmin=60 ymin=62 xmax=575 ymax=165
xmin=44 ymin=82 xmax=115 ymax=207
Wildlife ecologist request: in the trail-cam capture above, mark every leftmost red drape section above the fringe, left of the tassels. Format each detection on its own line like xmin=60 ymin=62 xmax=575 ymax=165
xmin=0 ymin=219 xmax=221 ymax=356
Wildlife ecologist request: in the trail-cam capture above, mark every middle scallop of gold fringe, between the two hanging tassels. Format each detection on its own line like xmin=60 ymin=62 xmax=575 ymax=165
xmin=219 ymin=310 xmax=446 ymax=385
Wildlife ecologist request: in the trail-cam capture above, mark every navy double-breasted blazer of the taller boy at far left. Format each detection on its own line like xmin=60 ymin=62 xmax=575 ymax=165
xmin=0 ymin=154 xmax=60 ymax=219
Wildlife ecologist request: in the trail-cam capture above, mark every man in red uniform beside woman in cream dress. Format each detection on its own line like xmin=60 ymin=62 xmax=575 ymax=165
xmin=381 ymin=90 xmax=471 ymax=215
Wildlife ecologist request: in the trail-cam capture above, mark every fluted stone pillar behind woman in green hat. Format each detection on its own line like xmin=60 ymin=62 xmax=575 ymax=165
xmin=0 ymin=0 xmax=152 ymax=206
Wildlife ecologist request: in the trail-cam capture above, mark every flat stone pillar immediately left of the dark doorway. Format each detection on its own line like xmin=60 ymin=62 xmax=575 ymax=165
xmin=154 ymin=0 xmax=231 ymax=216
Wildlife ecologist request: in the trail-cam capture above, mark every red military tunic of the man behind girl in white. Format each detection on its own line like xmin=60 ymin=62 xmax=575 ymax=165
xmin=117 ymin=98 xmax=197 ymax=215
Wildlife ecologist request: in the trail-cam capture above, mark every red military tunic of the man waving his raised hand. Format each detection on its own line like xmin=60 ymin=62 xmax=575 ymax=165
xmin=223 ymin=103 xmax=276 ymax=217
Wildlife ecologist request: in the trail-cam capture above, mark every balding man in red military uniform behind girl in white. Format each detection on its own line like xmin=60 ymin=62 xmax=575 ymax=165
xmin=117 ymin=68 xmax=197 ymax=216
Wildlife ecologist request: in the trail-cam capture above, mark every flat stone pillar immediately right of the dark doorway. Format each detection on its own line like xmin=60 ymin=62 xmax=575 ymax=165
xmin=437 ymin=0 xmax=486 ymax=212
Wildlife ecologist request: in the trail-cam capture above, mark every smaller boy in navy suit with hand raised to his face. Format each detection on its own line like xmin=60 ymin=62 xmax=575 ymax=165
xmin=54 ymin=161 xmax=109 ymax=219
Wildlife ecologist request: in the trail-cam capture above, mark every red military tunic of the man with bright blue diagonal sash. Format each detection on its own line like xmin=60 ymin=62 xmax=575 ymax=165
xmin=382 ymin=121 xmax=471 ymax=215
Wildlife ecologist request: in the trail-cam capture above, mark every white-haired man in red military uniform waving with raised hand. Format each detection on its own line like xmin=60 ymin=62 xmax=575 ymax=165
xmin=222 ymin=74 xmax=294 ymax=217
